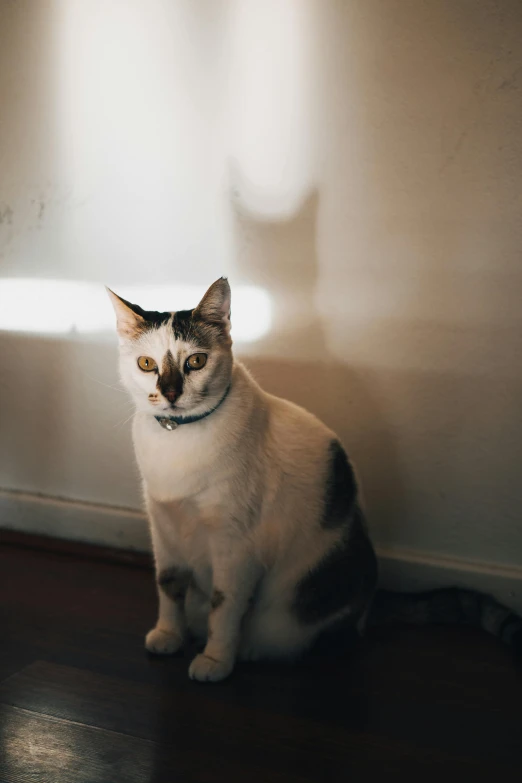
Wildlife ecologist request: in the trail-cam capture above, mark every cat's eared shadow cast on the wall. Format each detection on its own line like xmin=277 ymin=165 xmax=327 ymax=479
xmin=231 ymin=187 xmax=404 ymax=542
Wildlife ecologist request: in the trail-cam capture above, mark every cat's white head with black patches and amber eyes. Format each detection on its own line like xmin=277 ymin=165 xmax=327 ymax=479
xmin=107 ymin=277 xmax=232 ymax=416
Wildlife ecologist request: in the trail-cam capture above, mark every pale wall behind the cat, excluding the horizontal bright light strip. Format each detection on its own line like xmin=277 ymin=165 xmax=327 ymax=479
xmin=0 ymin=0 xmax=522 ymax=566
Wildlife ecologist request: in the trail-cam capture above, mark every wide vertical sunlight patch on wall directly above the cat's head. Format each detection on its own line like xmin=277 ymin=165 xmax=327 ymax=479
xmin=56 ymin=0 xmax=219 ymax=283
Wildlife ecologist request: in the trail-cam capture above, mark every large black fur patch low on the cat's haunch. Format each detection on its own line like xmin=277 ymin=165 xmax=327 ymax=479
xmin=292 ymin=508 xmax=377 ymax=625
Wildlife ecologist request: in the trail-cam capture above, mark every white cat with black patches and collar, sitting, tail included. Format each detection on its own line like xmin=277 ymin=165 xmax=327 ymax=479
xmin=107 ymin=278 xmax=522 ymax=682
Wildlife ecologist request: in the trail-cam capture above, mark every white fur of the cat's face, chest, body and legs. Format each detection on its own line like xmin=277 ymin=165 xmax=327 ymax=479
xmin=109 ymin=284 xmax=370 ymax=680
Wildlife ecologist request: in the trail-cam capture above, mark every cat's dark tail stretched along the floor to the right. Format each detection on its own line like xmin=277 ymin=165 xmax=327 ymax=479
xmin=366 ymin=587 xmax=522 ymax=659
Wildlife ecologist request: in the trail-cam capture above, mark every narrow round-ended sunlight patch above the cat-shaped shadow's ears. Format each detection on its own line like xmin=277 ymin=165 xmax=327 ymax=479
xmin=227 ymin=0 xmax=315 ymax=218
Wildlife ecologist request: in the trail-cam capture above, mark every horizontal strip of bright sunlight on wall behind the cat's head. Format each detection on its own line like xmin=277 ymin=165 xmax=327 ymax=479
xmin=0 ymin=278 xmax=272 ymax=343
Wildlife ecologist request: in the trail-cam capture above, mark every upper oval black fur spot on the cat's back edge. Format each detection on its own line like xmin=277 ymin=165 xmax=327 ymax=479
xmin=321 ymin=440 xmax=357 ymax=530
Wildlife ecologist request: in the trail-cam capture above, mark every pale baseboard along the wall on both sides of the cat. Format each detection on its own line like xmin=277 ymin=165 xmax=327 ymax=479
xmin=0 ymin=491 xmax=522 ymax=614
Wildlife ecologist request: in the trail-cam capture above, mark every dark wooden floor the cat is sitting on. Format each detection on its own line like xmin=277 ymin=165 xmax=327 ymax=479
xmin=0 ymin=534 xmax=522 ymax=783
